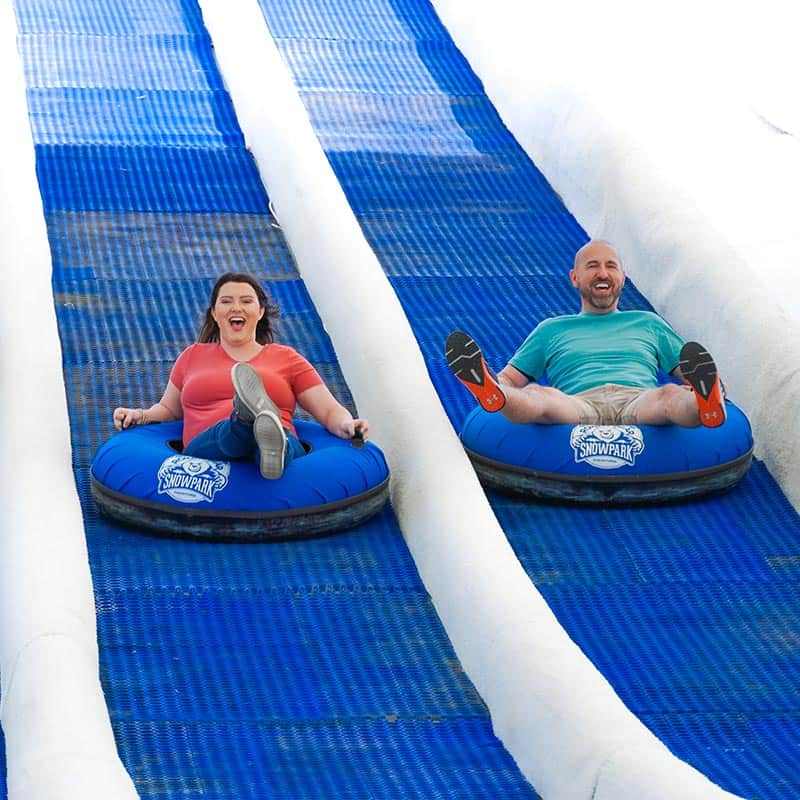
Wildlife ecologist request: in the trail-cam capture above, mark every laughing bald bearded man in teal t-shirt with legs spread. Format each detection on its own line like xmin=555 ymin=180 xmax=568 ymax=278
xmin=445 ymin=241 xmax=725 ymax=428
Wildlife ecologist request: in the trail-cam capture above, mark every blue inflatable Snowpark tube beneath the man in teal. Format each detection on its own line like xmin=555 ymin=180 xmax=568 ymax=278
xmin=461 ymin=401 xmax=753 ymax=505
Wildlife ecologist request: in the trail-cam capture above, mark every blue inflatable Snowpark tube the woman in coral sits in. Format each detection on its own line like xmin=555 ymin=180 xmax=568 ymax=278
xmin=91 ymin=420 xmax=389 ymax=541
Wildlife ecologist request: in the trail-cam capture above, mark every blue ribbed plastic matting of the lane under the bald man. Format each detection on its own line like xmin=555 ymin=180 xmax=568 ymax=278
xmin=255 ymin=0 xmax=800 ymax=800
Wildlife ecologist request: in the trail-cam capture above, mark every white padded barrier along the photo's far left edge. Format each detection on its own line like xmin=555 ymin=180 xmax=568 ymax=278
xmin=0 ymin=3 xmax=137 ymax=800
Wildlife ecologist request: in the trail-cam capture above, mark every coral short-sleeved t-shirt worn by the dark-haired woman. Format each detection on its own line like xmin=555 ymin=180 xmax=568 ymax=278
xmin=169 ymin=342 xmax=322 ymax=445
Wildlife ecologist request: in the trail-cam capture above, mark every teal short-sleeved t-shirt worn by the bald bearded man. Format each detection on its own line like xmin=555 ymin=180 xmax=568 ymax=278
xmin=509 ymin=311 xmax=683 ymax=394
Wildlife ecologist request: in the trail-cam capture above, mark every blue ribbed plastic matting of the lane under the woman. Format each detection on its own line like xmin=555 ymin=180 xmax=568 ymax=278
xmin=10 ymin=0 xmax=535 ymax=800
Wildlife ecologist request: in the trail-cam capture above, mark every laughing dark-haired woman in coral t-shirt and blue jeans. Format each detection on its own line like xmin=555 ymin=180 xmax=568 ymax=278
xmin=114 ymin=272 xmax=369 ymax=478
